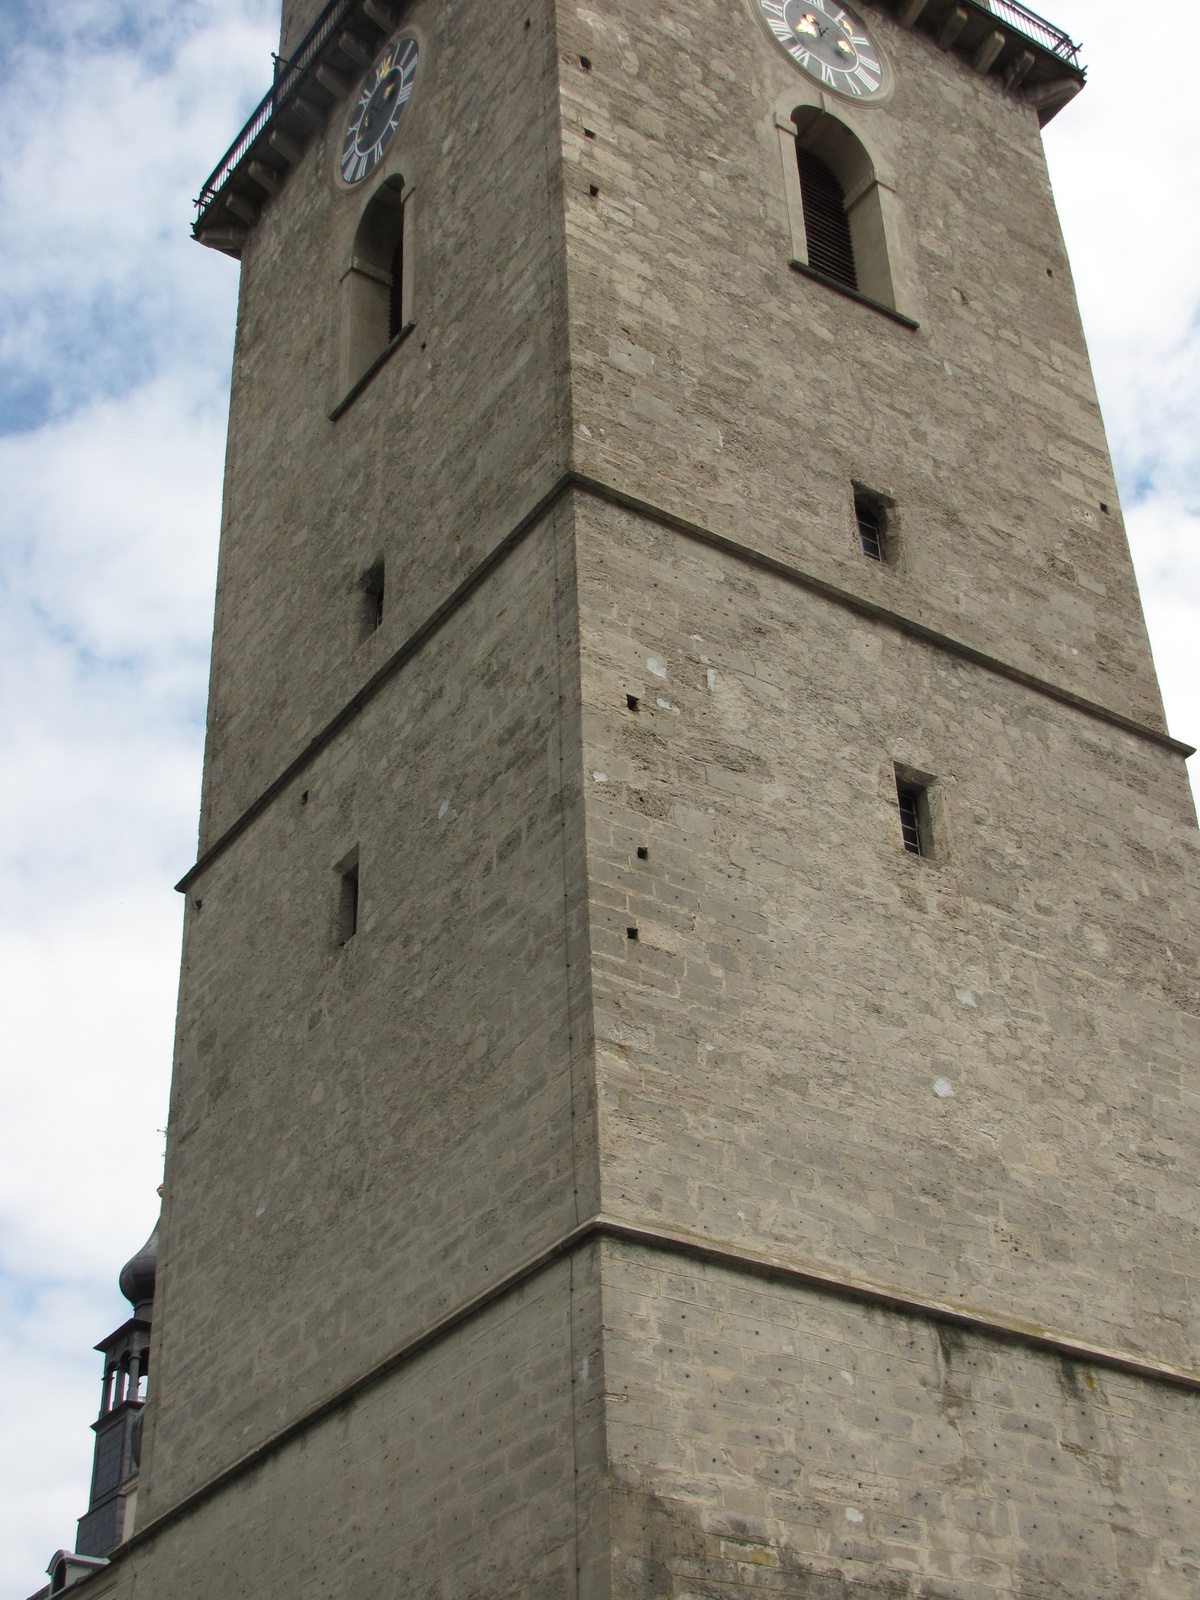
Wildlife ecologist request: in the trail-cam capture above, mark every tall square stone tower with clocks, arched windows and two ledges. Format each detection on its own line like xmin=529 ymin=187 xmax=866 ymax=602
xmin=61 ymin=0 xmax=1200 ymax=1600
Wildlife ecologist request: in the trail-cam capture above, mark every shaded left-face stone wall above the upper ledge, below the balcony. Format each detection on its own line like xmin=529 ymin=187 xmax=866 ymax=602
xmin=200 ymin=0 xmax=566 ymax=848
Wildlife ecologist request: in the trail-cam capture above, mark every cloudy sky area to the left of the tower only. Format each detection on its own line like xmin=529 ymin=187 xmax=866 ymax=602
xmin=0 ymin=0 xmax=277 ymax=1597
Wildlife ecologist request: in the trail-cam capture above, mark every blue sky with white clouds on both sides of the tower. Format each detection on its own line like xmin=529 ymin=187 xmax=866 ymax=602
xmin=0 ymin=0 xmax=1200 ymax=1600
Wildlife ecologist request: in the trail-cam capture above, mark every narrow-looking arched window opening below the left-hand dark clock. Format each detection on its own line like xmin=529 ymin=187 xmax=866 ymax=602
xmin=334 ymin=174 xmax=413 ymax=414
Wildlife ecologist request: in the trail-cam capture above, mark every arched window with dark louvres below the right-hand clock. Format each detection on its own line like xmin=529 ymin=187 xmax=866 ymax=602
xmin=778 ymin=106 xmax=915 ymax=326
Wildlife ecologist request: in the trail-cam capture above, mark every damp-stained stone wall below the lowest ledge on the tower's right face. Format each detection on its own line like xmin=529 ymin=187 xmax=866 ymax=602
xmin=603 ymin=1245 xmax=1200 ymax=1600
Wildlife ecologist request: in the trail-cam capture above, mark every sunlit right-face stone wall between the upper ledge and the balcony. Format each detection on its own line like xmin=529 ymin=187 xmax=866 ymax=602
xmin=558 ymin=0 xmax=1162 ymax=725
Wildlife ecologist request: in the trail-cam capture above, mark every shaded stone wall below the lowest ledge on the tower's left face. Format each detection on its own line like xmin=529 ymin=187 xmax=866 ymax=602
xmin=76 ymin=1251 xmax=608 ymax=1600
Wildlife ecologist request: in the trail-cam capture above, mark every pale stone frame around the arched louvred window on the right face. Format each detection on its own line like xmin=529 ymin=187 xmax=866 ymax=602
xmin=774 ymin=88 xmax=918 ymax=328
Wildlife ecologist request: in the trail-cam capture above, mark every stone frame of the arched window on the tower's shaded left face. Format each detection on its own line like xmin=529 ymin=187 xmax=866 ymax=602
xmin=330 ymin=173 xmax=416 ymax=421
